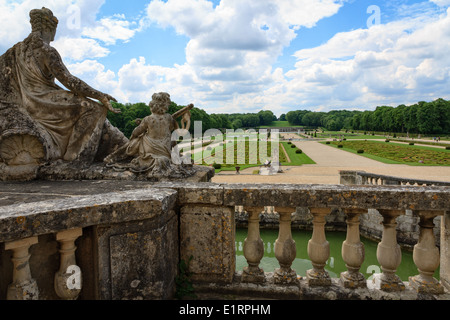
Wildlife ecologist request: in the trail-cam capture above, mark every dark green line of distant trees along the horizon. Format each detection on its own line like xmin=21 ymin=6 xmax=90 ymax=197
xmin=108 ymin=99 xmax=450 ymax=137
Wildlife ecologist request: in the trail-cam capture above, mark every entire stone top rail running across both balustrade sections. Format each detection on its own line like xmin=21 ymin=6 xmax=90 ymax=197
xmin=0 ymin=181 xmax=450 ymax=242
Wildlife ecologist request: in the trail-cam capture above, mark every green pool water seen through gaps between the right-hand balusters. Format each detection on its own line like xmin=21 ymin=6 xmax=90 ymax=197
xmin=236 ymin=229 xmax=439 ymax=281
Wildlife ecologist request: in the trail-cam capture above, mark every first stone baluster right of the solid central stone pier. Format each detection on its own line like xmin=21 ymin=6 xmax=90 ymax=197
xmin=242 ymin=207 xmax=265 ymax=283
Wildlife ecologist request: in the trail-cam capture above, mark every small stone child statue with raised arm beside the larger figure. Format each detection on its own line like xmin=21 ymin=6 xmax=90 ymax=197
xmin=105 ymin=92 xmax=194 ymax=176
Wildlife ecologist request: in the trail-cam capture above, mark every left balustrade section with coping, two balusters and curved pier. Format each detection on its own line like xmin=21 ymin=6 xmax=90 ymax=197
xmin=0 ymin=181 xmax=178 ymax=300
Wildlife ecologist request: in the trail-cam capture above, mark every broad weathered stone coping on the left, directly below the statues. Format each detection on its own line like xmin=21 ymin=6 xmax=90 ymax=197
xmin=0 ymin=182 xmax=177 ymax=242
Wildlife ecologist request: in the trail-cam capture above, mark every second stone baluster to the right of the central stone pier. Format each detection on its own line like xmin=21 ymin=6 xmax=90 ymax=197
xmin=274 ymin=207 xmax=297 ymax=284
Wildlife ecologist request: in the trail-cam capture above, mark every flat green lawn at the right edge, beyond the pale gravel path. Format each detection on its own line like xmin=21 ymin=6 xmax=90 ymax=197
xmin=329 ymin=141 xmax=450 ymax=166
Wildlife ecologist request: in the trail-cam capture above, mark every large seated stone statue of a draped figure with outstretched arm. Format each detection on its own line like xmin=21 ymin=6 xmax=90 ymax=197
xmin=0 ymin=8 xmax=128 ymax=179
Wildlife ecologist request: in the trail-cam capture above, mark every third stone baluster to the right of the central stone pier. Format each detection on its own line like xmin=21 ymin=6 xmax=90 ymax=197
xmin=306 ymin=208 xmax=331 ymax=286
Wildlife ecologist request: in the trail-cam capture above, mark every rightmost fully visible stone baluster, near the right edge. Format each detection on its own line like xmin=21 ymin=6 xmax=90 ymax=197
xmin=409 ymin=211 xmax=444 ymax=294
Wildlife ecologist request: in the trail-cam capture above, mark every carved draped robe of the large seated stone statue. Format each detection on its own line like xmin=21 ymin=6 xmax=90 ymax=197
xmin=0 ymin=35 xmax=107 ymax=160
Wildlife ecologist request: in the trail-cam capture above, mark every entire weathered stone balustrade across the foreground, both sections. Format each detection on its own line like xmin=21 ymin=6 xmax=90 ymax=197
xmin=0 ymin=182 xmax=450 ymax=299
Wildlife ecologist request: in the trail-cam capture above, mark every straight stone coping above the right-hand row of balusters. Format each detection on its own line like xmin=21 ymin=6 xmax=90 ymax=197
xmin=157 ymin=183 xmax=450 ymax=211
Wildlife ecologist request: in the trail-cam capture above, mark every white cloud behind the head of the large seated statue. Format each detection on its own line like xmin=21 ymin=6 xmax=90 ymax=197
xmin=0 ymin=0 xmax=140 ymax=61
